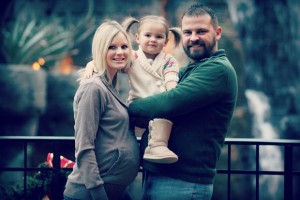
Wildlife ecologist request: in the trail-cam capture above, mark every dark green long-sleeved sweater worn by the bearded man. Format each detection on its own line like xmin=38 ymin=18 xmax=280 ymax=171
xmin=129 ymin=50 xmax=237 ymax=184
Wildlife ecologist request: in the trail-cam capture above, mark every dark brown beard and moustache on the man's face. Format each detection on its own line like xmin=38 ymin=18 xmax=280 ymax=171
xmin=183 ymin=38 xmax=217 ymax=61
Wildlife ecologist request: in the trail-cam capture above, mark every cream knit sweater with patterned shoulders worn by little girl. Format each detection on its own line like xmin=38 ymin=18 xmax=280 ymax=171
xmin=127 ymin=48 xmax=179 ymax=103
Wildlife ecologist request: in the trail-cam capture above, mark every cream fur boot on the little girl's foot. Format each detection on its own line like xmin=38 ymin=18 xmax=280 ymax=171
xmin=144 ymin=119 xmax=178 ymax=163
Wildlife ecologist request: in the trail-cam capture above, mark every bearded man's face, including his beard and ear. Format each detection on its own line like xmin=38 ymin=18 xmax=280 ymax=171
xmin=182 ymin=14 xmax=222 ymax=62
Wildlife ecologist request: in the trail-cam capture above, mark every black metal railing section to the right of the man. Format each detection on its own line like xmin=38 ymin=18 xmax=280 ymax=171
xmin=217 ymin=138 xmax=300 ymax=200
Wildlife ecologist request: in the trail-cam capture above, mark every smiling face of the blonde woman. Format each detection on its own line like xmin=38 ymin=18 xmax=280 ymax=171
xmin=106 ymin=32 xmax=130 ymax=77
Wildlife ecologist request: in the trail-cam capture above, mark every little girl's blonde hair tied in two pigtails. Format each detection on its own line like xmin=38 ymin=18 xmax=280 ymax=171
xmin=122 ymin=15 xmax=181 ymax=46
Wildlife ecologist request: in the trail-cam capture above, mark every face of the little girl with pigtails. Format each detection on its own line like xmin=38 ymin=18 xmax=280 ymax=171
xmin=136 ymin=21 xmax=167 ymax=59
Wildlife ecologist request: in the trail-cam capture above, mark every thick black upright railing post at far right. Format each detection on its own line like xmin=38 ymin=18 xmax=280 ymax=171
xmin=284 ymin=145 xmax=293 ymax=200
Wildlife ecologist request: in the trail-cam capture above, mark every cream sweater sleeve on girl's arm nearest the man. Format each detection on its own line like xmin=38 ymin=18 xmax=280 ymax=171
xmin=164 ymin=54 xmax=179 ymax=91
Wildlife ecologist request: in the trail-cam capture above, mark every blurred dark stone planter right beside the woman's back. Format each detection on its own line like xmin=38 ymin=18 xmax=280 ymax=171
xmin=38 ymin=72 xmax=79 ymax=136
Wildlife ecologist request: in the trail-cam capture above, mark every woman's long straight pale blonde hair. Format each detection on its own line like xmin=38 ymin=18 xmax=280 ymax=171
xmin=79 ymin=20 xmax=132 ymax=81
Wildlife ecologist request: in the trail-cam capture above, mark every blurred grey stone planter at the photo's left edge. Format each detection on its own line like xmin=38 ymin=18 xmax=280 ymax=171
xmin=0 ymin=64 xmax=46 ymax=136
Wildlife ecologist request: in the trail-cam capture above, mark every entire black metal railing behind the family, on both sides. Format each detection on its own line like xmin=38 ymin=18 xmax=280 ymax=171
xmin=0 ymin=136 xmax=300 ymax=200
